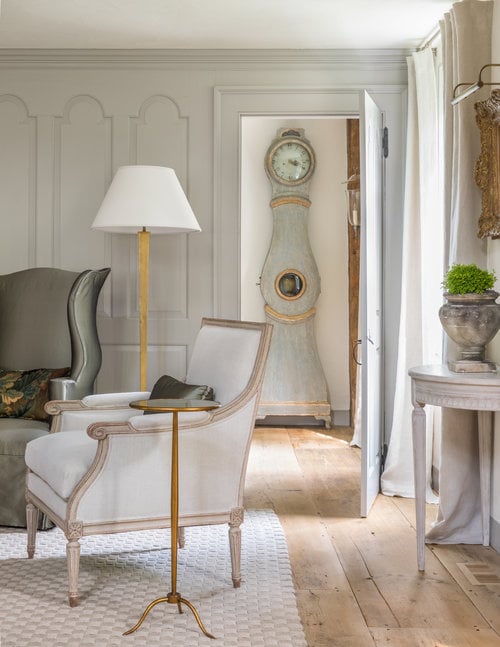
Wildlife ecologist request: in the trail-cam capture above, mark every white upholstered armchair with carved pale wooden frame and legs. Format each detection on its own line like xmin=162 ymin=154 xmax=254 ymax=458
xmin=26 ymin=319 xmax=272 ymax=606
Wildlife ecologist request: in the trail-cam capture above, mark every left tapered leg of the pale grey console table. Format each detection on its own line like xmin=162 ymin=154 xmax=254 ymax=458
xmin=412 ymin=402 xmax=426 ymax=571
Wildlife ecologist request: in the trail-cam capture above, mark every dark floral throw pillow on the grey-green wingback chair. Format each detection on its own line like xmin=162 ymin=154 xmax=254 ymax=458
xmin=0 ymin=368 xmax=70 ymax=422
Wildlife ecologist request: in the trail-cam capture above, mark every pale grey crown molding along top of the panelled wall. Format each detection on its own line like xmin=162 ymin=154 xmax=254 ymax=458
xmin=0 ymin=49 xmax=410 ymax=70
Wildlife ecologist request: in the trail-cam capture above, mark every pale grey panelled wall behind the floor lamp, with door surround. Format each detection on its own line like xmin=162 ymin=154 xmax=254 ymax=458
xmin=0 ymin=50 xmax=406 ymax=436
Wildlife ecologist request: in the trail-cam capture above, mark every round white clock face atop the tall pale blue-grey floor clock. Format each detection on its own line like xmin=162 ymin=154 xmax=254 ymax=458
xmin=267 ymin=139 xmax=314 ymax=184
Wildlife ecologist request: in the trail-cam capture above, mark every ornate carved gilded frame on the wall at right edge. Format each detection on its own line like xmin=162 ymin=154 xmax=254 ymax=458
xmin=474 ymin=90 xmax=500 ymax=238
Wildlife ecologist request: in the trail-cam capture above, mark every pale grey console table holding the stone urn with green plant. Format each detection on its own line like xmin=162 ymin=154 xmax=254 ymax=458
xmin=408 ymin=364 xmax=500 ymax=571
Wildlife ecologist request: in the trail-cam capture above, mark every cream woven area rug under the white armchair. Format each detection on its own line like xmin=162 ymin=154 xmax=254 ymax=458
xmin=0 ymin=510 xmax=306 ymax=647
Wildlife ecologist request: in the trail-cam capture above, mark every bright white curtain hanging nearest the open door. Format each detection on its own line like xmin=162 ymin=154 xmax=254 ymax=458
xmin=381 ymin=47 xmax=444 ymax=501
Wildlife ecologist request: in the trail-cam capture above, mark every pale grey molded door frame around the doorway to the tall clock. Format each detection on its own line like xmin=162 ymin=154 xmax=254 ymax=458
xmin=213 ymin=84 xmax=406 ymax=512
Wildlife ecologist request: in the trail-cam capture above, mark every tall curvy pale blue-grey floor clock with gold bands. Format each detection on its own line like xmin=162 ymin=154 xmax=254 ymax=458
xmin=258 ymin=128 xmax=331 ymax=427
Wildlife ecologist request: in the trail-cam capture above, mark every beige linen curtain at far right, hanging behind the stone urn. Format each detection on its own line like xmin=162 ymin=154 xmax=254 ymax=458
xmin=427 ymin=0 xmax=493 ymax=544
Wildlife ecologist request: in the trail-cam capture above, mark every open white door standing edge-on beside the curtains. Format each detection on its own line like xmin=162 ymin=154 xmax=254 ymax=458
xmin=359 ymin=92 xmax=384 ymax=517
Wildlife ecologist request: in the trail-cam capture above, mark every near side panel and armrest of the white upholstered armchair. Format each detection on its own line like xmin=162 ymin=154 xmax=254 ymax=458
xmin=73 ymin=397 xmax=262 ymax=523
